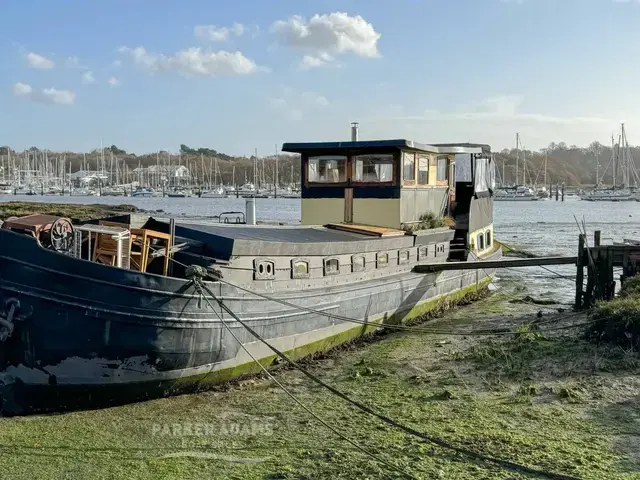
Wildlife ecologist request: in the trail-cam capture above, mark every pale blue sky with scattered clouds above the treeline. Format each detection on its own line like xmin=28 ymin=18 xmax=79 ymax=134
xmin=0 ymin=0 xmax=640 ymax=155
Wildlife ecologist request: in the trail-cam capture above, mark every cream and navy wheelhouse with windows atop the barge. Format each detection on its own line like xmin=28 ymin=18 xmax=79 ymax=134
xmin=283 ymin=139 xmax=493 ymax=243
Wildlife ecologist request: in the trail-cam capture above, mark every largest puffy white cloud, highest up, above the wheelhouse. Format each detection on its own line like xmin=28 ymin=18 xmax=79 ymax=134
xmin=270 ymin=12 xmax=381 ymax=68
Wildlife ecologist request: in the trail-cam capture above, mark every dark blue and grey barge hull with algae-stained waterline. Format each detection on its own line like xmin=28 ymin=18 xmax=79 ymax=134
xmin=0 ymin=230 xmax=501 ymax=415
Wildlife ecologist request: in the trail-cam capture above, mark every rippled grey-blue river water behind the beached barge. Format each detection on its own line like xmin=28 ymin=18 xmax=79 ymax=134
xmin=5 ymin=195 xmax=640 ymax=302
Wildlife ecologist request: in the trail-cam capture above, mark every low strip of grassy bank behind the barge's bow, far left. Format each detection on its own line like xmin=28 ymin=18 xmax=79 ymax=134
xmin=0 ymin=202 xmax=137 ymax=221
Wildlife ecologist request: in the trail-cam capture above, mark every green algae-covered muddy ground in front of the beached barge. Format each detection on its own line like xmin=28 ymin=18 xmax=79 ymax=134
xmin=0 ymin=290 xmax=640 ymax=480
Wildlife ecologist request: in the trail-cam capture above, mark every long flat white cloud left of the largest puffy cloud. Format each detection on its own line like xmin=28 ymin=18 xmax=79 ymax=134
xmin=118 ymin=47 xmax=259 ymax=77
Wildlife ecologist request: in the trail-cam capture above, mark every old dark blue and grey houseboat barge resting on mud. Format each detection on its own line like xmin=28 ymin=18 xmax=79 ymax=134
xmin=0 ymin=130 xmax=501 ymax=415
